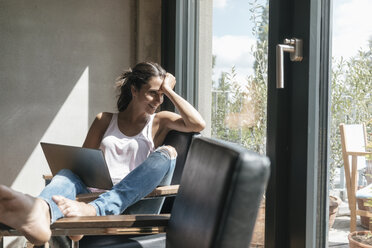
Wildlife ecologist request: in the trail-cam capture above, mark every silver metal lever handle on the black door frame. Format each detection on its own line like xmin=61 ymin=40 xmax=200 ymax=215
xmin=276 ymin=38 xmax=303 ymax=89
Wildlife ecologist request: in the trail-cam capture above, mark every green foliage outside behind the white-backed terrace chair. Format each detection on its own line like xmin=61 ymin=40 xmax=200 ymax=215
xmin=330 ymin=39 xmax=372 ymax=188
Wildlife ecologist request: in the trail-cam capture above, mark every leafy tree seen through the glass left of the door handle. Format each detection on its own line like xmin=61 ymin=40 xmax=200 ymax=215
xmin=212 ymin=0 xmax=269 ymax=153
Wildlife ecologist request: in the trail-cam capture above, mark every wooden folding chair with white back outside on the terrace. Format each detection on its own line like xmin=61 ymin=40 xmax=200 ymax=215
xmin=340 ymin=124 xmax=372 ymax=232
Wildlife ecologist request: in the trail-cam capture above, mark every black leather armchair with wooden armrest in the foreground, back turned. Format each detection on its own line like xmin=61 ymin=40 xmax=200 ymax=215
xmin=0 ymin=137 xmax=269 ymax=248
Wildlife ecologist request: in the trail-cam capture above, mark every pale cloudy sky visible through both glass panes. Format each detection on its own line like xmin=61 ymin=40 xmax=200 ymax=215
xmin=212 ymin=0 xmax=372 ymax=84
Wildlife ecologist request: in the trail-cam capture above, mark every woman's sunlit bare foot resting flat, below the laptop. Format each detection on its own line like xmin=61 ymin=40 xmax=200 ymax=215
xmin=52 ymin=195 xmax=97 ymax=217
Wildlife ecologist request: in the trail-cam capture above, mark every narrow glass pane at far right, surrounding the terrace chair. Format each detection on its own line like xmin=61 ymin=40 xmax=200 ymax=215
xmin=328 ymin=0 xmax=372 ymax=247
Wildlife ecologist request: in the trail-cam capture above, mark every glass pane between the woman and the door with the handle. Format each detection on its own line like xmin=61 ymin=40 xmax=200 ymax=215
xmin=211 ymin=0 xmax=269 ymax=247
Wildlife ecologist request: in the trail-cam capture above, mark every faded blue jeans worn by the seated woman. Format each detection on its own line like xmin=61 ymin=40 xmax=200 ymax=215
xmin=39 ymin=148 xmax=176 ymax=223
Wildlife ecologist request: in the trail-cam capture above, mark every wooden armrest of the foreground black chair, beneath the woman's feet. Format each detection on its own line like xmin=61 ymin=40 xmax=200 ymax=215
xmin=0 ymin=214 xmax=170 ymax=236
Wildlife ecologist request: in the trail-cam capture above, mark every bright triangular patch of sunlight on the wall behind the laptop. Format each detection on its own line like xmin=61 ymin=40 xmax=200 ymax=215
xmin=12 ymin=67 xmax=89 ymax=196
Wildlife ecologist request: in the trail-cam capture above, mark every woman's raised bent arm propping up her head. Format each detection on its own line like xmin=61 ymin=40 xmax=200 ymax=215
xmin=157 ymin=73 xmax=205 ymax=132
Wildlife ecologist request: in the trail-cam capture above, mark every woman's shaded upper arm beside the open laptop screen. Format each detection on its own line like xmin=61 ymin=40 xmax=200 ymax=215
xmin=83 ymin=112 xmax=112 ymax=149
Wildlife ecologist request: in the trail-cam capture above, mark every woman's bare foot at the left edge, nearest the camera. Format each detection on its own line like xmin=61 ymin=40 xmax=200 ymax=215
xmin=0 ymin=185 xmax=51 ymax=245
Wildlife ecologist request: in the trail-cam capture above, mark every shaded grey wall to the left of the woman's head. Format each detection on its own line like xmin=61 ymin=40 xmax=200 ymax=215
xmin=0 ymin=0 xmax=134 ymax=189
